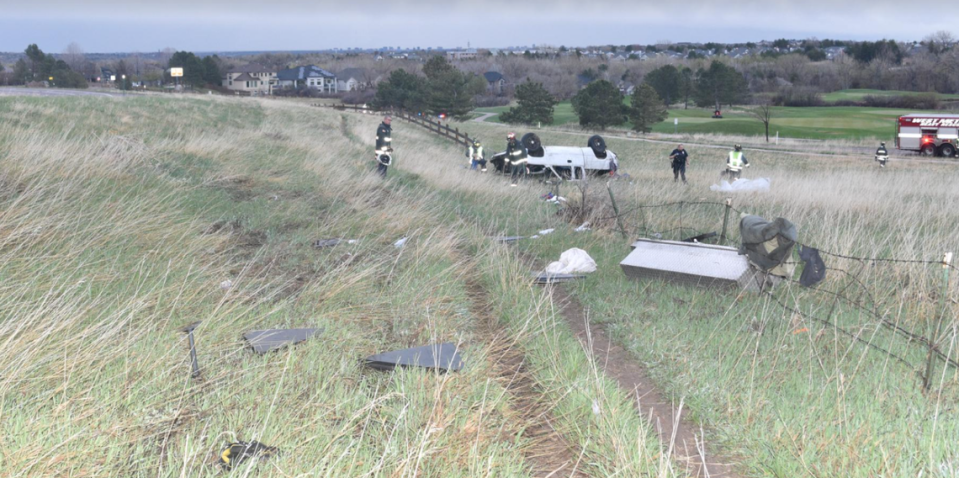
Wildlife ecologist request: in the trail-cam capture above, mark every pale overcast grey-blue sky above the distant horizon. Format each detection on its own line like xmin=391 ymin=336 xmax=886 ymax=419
xmin=0 ymin=0 xmax=959 ymax=52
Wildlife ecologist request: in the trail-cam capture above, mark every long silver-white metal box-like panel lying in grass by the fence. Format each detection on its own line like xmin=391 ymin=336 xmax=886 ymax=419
xmin=619 ymin=239 xmax=762 ymax=290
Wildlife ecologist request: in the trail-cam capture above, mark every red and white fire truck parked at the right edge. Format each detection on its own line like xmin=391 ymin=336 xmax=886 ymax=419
xmin=896 ymin=113 xmax=959 ymax=158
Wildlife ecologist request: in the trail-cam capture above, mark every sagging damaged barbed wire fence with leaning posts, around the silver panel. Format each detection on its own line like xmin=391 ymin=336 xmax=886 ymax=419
xmin=593 ymin=197 xmax=959 ymax=391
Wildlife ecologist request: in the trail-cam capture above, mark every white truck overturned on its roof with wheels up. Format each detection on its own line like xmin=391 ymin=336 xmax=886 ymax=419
xmin=490 ymin=133 xmax=619 ymax=180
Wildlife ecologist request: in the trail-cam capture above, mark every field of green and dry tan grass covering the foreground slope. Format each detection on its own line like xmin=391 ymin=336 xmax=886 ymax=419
xmin=0 ymin=97 xmax=959 ymax=477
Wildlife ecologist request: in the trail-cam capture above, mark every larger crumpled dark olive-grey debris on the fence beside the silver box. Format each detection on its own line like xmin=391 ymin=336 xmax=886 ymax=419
xmin=739 ymin=216 xmax=798 ymax=275
